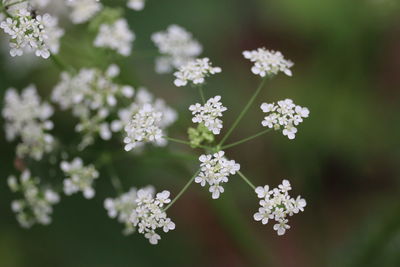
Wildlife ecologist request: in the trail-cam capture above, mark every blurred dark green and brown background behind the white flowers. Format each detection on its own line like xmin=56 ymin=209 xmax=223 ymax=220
xmin=0 ymin=0 xmax=400 ymax=267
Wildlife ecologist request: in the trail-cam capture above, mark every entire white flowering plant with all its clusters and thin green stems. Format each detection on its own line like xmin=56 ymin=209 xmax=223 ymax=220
xmin=0 ymin=0 xmax=310 ymax=244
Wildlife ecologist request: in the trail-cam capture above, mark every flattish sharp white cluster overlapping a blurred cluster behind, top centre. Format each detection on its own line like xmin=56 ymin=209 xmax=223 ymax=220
xmin=174 ymin=58 xmax=221 ymax=87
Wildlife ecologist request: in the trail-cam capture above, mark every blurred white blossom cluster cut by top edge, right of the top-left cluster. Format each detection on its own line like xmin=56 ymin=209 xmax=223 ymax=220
xmin=65 ymin=0 xmax=103 ymax=24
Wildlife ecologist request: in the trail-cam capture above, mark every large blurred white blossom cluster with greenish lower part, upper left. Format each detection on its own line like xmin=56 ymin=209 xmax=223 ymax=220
xmin=52 ymin=65 xmax=134 ymax=148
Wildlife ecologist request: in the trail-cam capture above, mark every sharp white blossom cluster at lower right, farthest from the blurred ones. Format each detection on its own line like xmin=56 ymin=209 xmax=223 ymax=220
xmin=254 ymin=180 xmax=307 ymax=235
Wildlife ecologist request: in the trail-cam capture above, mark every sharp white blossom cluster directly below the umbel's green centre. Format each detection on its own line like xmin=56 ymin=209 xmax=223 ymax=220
xmin=194 ymin=151 xmax=240 ymax=199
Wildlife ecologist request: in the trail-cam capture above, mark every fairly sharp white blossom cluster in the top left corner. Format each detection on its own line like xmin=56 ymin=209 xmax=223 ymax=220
xmin=0 ymin=9 xmax=54 ymax=58
